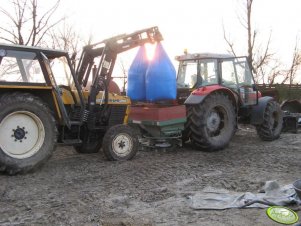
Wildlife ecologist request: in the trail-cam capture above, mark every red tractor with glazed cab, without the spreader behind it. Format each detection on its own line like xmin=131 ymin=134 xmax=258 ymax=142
xmin=176 ymin=53 xmax=283 ymax=150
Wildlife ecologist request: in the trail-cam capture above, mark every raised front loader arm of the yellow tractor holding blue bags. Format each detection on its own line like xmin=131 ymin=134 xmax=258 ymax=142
xmin=76 ymin=27 xmax=163 ymax=130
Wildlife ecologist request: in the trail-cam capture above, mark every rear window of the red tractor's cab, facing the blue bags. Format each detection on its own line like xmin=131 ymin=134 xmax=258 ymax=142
xmin=177 ymin=59 xmax=218 ymax=88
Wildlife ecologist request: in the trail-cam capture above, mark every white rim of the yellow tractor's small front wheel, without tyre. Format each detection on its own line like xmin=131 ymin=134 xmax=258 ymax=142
xmin=112 ymin=133 xmax=133 ymax=157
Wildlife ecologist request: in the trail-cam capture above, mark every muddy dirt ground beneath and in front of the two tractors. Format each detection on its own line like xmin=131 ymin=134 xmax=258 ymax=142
xmin=0 ymin=127 xmax=301 ymax=226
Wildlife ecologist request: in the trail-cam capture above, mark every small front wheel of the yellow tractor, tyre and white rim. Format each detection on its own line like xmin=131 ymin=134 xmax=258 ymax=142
xmin=102 ymin=125 xmax=139 ymax=161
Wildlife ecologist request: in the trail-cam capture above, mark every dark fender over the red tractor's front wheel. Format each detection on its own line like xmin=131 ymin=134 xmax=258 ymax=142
xmin=251 ymin=96 xmax=274 ymax=125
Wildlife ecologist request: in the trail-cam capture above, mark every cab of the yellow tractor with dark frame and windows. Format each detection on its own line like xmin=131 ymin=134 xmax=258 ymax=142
xmin=0 ymin=44 xmax=84 ymax=125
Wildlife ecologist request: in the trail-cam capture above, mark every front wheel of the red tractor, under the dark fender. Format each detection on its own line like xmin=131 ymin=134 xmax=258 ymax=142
xmin=256 ymin=101 xmax=283 ymax=141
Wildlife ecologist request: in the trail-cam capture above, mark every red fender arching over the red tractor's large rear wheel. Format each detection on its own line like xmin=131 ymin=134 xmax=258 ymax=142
xmin=184 ymin=85 xmax=237 ymax=106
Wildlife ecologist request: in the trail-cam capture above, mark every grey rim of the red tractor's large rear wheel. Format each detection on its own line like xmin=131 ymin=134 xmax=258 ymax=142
xmin=206 ymin=106 xmax=228 ymax=137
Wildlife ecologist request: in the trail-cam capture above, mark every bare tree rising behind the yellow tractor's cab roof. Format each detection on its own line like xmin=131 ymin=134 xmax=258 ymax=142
xmin=0 ymin=0 xmax=64 ymax=46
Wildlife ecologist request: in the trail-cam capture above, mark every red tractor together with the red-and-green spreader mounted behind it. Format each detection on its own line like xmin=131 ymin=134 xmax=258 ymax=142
xmin=129 ymin=53 xmax=283 ymax=151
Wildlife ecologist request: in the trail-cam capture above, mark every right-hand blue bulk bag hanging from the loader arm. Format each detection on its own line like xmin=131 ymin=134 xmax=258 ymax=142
xmin=145 ymin=43 xmax=177 ymax=101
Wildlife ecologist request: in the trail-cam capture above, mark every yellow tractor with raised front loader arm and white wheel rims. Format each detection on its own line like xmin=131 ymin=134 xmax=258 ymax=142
xmin=0 ymin=27 xmax=162 ymax=174
